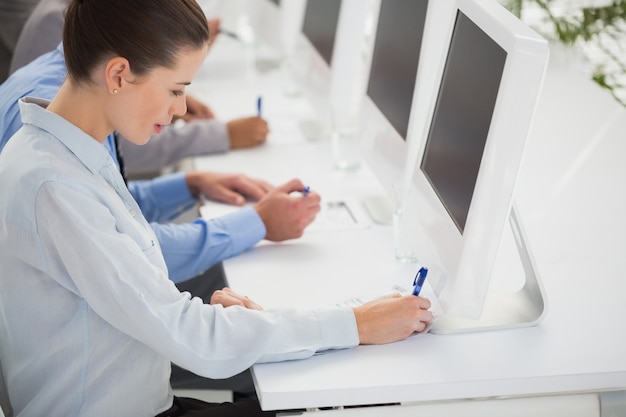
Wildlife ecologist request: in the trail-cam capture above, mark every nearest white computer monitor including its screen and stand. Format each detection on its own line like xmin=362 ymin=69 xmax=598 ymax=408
xmin=405 ymin=0 xmax=548 ymax=332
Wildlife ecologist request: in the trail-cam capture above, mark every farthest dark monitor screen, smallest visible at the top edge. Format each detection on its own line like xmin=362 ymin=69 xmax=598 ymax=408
xmin=302 ymin=0 xmax=341 ymax=65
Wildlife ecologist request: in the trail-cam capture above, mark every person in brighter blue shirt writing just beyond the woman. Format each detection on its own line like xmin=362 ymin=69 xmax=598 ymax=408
xmin=0 ymin=45 xmax=320 ymax=282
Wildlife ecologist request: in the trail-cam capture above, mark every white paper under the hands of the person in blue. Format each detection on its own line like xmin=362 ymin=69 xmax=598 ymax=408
xmin=200 ymin=197 xmax=372 ymax=232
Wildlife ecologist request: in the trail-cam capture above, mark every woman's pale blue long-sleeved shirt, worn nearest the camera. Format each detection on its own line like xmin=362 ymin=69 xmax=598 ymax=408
xmin=0 ymin=98 xmax=358 ymax=417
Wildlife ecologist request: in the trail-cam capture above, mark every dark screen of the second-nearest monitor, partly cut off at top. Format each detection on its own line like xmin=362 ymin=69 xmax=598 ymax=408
xmin=367 ymin=0 xmax=428 ymax=139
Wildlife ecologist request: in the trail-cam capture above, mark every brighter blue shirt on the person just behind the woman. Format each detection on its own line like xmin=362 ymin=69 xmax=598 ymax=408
xmin=0 ymin=45 xmax=266 ymax=282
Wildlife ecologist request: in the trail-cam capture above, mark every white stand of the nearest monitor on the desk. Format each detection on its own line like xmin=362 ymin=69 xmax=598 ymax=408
xmin=430 ymin=205 xmax=546 ymax=334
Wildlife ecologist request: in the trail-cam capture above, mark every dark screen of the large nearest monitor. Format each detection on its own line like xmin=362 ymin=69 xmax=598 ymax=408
xmin=421 ymin=11 xmax=506 ymax=233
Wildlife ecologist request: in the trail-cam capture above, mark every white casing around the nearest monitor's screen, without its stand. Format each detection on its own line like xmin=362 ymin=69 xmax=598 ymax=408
xmin=405 ymin=0 xmax=549 ymax=319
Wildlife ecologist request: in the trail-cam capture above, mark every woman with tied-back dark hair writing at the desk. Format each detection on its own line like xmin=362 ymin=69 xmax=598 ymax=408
xmin=0 ymin=0 xmax=432 ymax=417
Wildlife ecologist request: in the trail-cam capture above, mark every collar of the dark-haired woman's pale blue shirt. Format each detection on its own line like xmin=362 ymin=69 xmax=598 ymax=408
xmin=19 ymin=97 xmax=113 ymax=173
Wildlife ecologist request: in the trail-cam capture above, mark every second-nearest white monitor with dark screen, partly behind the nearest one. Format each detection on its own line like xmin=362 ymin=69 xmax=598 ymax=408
xmin=359 ymin=0 xmax=428 ymax=224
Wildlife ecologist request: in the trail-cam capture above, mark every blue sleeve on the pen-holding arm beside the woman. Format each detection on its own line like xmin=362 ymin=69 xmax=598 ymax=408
xmin=150 ymin=207 xmax=267 ymax=282
